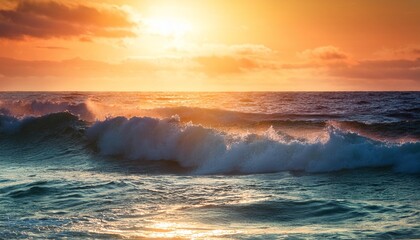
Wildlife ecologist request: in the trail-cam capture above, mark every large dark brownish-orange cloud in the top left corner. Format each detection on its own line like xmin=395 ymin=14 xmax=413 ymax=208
xmin=0 ymin=0 xmax=135 ymax=39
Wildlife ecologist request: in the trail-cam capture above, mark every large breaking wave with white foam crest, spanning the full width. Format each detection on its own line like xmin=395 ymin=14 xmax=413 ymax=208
xmin=0 ymin=112 xmax=420 ymax=174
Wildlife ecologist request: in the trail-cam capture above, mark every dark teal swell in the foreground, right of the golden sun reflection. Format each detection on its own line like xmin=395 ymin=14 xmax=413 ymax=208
xmin=192 ymin=200 xmax=380 ymax=224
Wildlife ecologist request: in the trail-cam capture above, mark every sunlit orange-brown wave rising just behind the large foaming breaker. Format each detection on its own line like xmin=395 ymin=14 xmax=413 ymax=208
xmin=0 ymin=100 xmax=420 ymax=142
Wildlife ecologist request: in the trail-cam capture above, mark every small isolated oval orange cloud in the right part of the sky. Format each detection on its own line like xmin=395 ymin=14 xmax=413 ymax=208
xmin=298 ymin=46 xmax=349 ymax=62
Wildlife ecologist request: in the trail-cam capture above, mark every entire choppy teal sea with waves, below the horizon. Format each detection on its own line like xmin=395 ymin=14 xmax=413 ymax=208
xmin=0 ymin=92 xmax=420 ymax=239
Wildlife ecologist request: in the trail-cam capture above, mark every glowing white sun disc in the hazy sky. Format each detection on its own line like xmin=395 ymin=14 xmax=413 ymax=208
xmin=145 ymin=17 xmax=192 ymax=38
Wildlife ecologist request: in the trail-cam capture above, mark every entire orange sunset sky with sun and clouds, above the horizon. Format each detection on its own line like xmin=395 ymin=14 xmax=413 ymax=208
xmin=0 ymin=0 xmax=420 ymax=91
